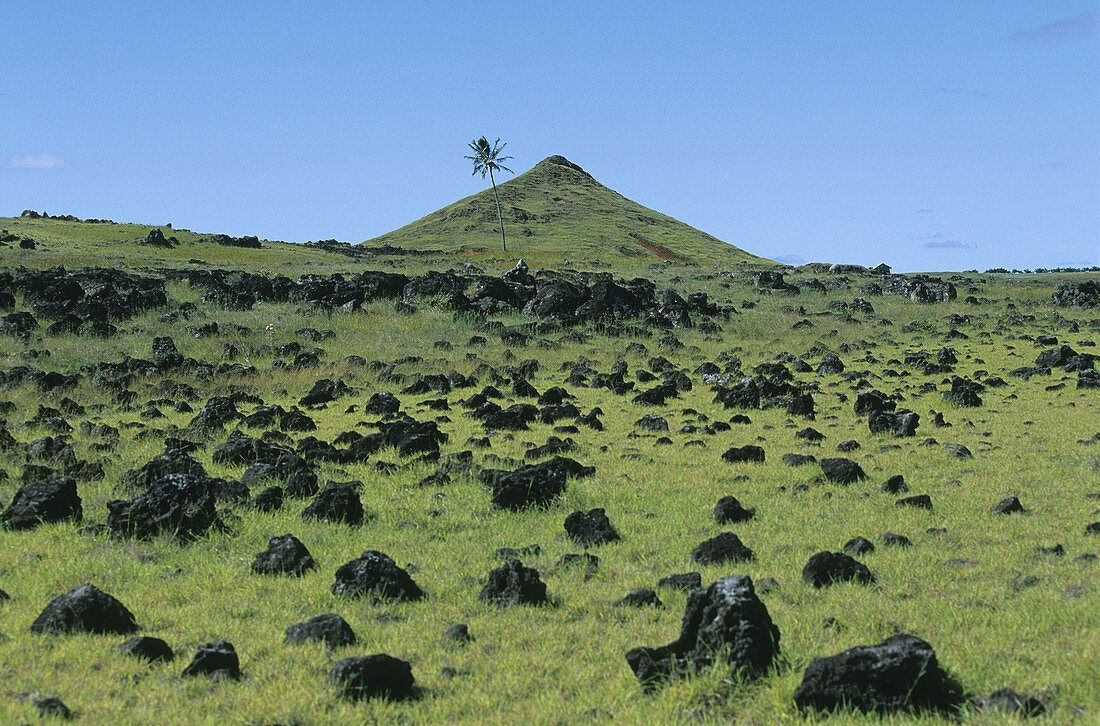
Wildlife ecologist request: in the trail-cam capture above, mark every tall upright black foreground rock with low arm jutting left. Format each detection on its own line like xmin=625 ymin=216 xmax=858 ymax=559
xmin=626 ymin=575 xmax=780 ymax=691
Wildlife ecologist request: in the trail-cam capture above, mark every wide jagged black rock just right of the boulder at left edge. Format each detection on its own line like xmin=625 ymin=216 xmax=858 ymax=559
xmin=107 ymin=474 xmax=219 ymax=541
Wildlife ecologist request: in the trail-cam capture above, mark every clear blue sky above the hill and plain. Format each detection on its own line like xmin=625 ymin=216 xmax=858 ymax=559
xmin=0 ymin=0 xmax=1100 ymax=272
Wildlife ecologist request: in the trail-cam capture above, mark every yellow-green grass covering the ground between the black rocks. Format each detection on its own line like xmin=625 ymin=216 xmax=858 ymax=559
xmin=0 ymin=246 xmax=1100 ymax=724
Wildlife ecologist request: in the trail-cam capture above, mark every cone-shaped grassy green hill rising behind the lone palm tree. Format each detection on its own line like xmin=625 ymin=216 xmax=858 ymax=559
xmin=365 ymin=154 xmax=767 ymax=264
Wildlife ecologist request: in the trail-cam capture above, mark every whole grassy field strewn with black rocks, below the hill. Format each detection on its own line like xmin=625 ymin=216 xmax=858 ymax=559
xmin=0 ymin=235 xmax=1100 ymax=725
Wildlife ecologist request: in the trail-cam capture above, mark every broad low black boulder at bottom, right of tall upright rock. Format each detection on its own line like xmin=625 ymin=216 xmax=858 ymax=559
xmin=794 ymin=634 xmax=961 ymax=714
